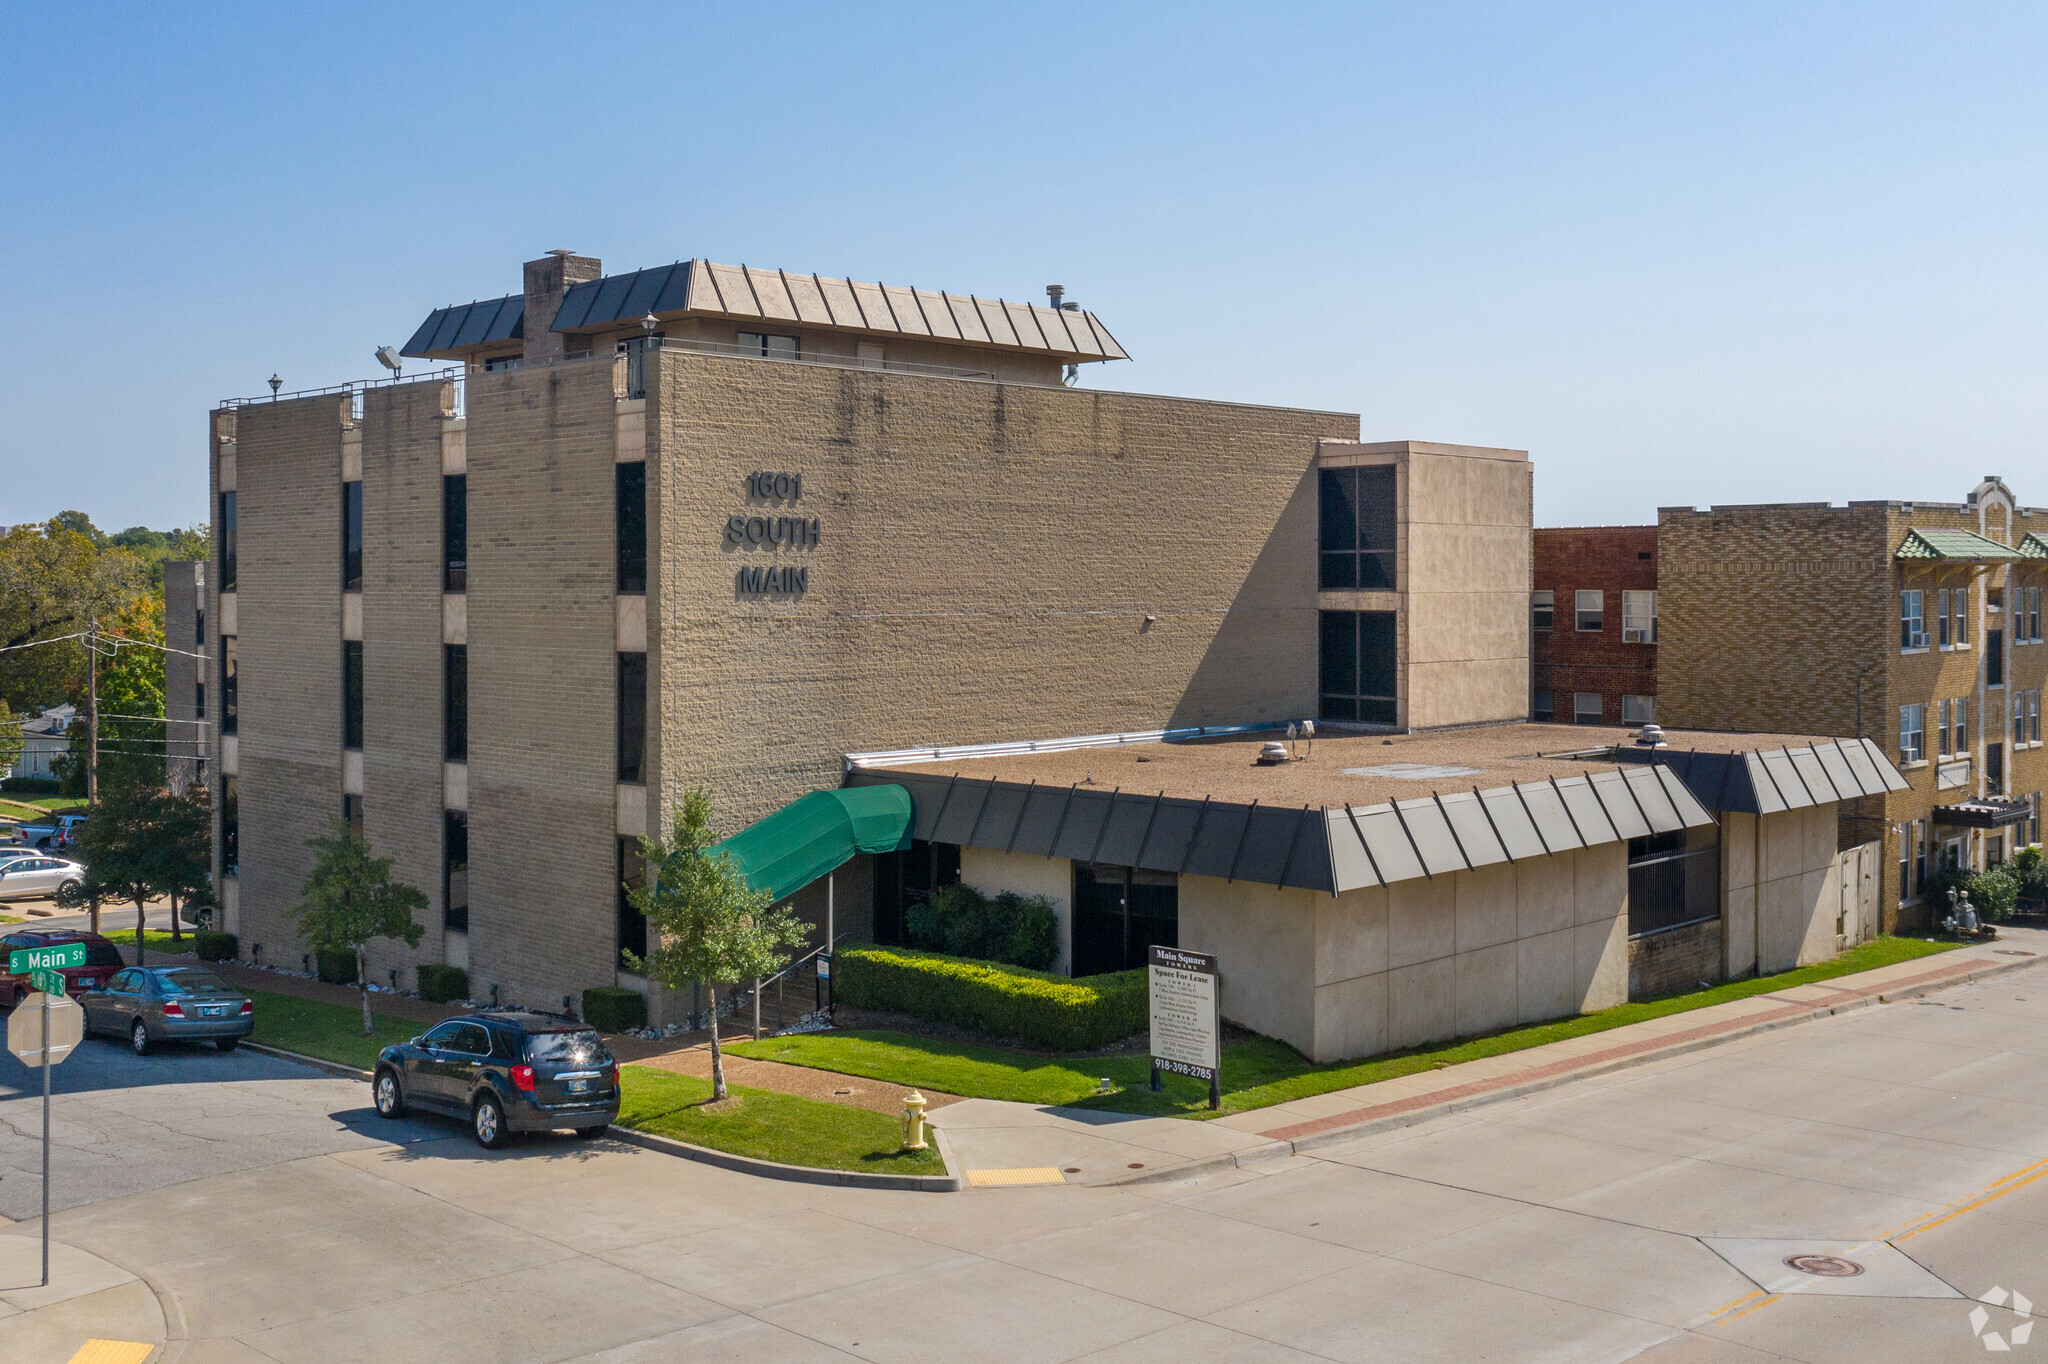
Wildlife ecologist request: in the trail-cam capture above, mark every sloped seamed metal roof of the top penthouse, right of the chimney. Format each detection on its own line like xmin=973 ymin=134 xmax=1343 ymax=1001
xmin=544 ymin=260 xmax=1130 ymax=360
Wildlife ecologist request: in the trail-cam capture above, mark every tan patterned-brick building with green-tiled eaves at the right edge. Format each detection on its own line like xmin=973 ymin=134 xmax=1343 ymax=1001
xmin=1657 ymin=477 xmax=2048 ymax=930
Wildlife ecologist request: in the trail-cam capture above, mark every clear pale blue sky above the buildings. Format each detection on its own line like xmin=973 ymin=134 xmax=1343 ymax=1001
xmin=0 ymin=4 xmax=2048 ymax=528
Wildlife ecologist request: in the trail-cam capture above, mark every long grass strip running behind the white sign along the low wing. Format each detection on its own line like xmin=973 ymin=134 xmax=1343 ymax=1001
xmin=729 ymin=938 xmax=1956 ymax=1118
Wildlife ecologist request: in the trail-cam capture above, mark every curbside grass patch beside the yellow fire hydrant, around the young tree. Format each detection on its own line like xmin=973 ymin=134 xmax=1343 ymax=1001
xmin=614 ymin=1064 xmax=946 ymax=1174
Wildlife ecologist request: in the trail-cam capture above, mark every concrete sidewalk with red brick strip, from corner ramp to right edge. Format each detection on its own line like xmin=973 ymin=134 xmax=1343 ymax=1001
xmin=932 ymin=928 xmax=2048 ymax=1186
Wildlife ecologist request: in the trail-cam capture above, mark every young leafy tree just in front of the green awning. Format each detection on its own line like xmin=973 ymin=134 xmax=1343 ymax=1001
xmin=623 ymin=788 xmax=805 ymax=1100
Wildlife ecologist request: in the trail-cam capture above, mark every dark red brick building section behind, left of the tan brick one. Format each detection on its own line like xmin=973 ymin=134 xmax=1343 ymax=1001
xmin=1530 ymin=526 xmax=1657 ymax=725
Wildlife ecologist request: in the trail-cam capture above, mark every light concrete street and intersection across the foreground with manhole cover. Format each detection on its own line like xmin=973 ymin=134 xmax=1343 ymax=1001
xmin=0 ymin=950 xmax=2048 ymax=1364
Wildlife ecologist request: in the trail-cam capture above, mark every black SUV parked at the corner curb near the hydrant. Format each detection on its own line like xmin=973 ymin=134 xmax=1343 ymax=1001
xmin=371 ymin=1012 xmax=618 ymax=1149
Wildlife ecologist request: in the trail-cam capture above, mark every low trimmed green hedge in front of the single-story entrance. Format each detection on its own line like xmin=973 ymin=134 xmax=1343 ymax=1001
xmin=831 ymin=946 xmax=1151 ymax=1051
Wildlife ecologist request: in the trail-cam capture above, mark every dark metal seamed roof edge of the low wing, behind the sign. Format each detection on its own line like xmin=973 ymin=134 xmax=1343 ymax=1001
xmin=846 ymin=766 xmax=1714 ymax=895
